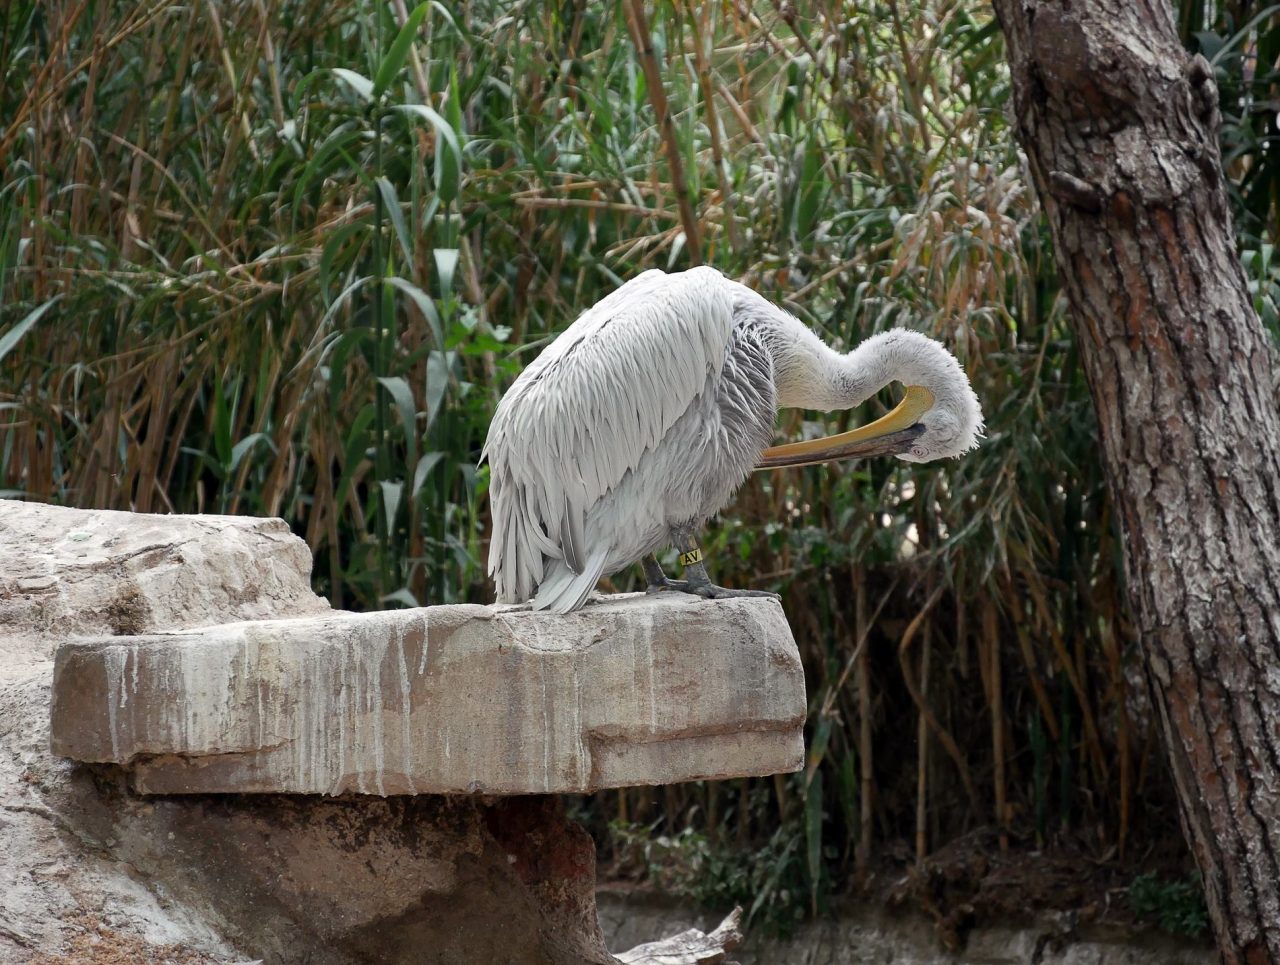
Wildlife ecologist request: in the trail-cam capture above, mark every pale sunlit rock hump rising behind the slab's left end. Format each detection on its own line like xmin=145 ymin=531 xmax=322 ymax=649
xmin=0 ymin=499 xmax=329 ymax=671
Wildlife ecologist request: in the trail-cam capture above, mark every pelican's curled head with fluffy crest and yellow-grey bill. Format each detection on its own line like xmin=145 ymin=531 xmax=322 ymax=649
xmin=758 ymin=329 xmax=982 ymax=468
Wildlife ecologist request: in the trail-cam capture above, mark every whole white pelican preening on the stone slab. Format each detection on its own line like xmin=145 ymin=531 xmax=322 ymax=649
xmin=481 ymin=267 xmax=982 ymax=613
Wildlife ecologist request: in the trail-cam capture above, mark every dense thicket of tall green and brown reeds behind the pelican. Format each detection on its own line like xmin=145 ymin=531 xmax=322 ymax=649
xmin=0 ymin=0 xmax=1280 ymax=931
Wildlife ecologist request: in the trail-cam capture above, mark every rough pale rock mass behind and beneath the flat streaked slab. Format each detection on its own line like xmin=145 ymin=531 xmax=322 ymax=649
xmin=0 ymin=500 xmax=612 ymax=965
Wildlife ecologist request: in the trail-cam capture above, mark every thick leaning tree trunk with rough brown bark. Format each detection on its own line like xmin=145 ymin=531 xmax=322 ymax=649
xmin=995 ymin=0 xmax=1280 ymax=962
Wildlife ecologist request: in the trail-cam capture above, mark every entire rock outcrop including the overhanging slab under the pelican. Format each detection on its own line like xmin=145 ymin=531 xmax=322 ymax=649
xmin=0 ymin=502 xmax=803 ymax=965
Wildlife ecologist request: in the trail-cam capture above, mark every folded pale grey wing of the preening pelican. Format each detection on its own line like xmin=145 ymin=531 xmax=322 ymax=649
xmin=485 ymin=269 xmax=733 ymax=602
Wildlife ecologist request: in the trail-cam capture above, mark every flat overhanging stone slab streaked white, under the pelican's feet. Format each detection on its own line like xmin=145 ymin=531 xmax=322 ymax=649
xmin=51 ymin=594 xmax=805 ymax=796
